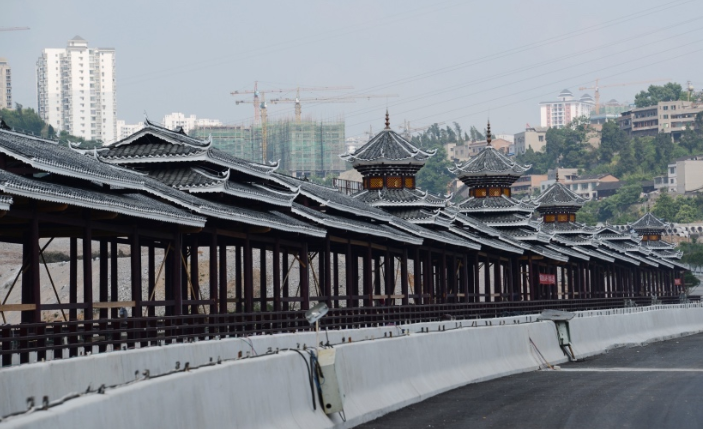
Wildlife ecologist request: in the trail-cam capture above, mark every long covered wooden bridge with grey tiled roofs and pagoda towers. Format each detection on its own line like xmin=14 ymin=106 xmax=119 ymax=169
xmin=0 ymin=120 xmax=683 ymax=365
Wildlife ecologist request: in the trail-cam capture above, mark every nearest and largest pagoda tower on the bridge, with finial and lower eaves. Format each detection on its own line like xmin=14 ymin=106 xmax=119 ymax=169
xmin=341 ymin=111 xmax=451 ymax=223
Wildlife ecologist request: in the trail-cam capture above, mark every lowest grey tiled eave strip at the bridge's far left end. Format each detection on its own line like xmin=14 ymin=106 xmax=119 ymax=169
xmin=0 ymin=170 xmax=205 ymax=226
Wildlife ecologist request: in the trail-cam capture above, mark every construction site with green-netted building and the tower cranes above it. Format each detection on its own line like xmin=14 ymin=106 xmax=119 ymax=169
xmin=190 ymin=82 xmax=397 ymax=177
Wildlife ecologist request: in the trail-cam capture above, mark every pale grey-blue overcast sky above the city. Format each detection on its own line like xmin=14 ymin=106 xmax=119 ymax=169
xmin=0 ymin=0 xmax=703 ymax=136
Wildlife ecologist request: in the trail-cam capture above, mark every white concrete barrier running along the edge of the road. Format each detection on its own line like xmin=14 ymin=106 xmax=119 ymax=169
xmin=0 ymin=305 xmax=703 ymax=429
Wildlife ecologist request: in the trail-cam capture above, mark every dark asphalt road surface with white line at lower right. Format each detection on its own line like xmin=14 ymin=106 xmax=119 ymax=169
xmin=358 ymin=334 xmax=703 ymax=429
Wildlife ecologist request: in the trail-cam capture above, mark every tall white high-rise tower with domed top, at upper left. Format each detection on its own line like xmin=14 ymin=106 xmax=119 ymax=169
xmin=37 ymin=36 xmax=117 ymax=143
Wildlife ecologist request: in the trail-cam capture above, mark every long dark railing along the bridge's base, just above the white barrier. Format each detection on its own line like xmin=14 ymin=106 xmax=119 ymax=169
xmin=0 ymin=297 xmax=678 ymax=366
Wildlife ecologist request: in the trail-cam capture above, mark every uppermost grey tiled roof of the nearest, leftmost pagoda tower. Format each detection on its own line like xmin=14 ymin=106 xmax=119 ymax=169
xmin=340 ymin=128 xmax=437 ymax=166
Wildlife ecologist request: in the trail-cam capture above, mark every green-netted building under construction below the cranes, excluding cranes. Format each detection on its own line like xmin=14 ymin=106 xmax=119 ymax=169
xmin=190 ymin=119 xmax=347 ymax=177
